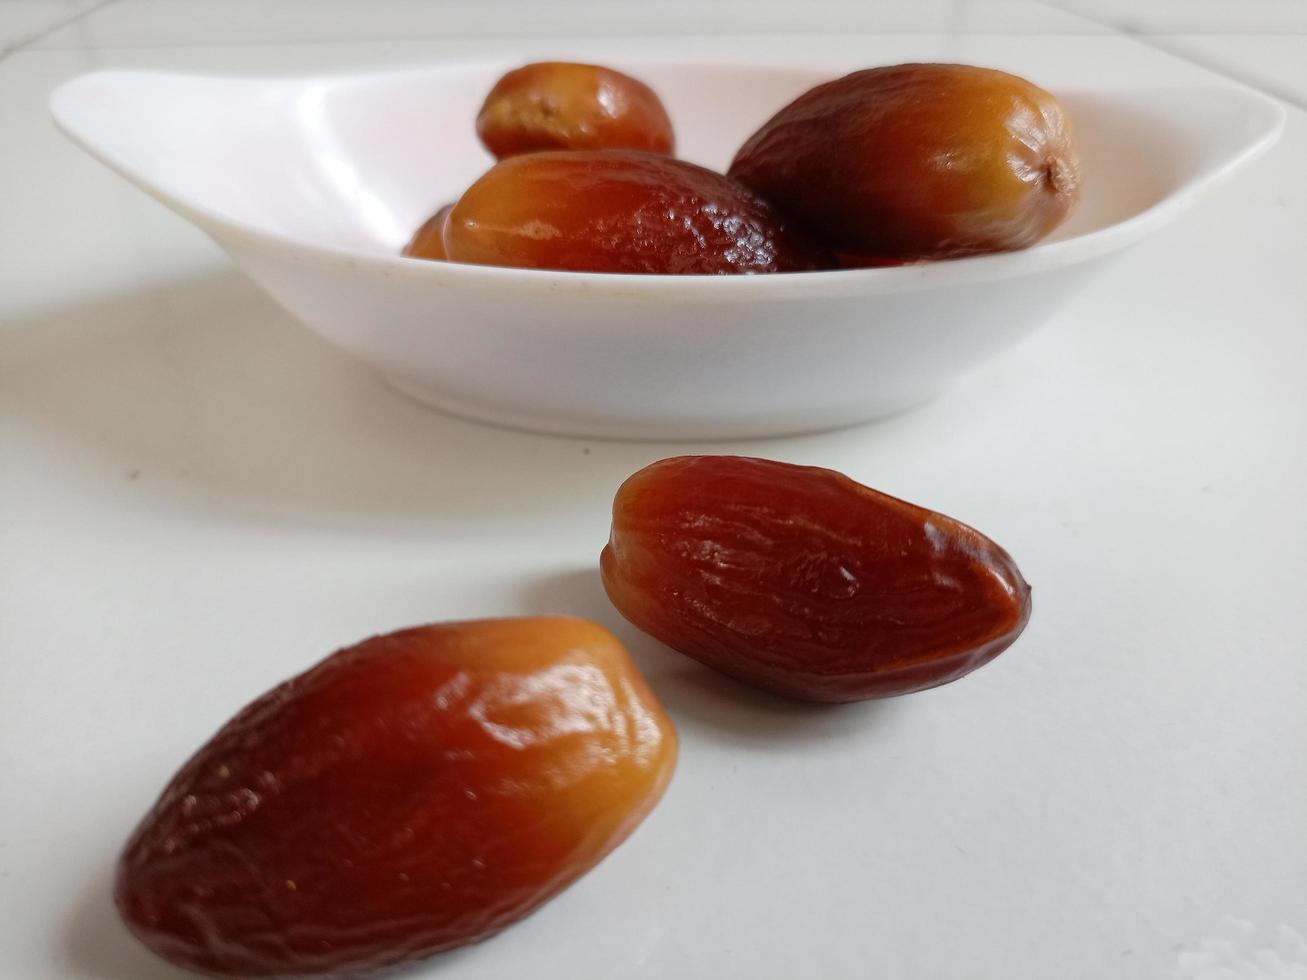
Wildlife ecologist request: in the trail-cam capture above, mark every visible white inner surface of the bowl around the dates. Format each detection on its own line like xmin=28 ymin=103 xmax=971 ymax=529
xmin=54 ymin=61 xmax=1280 ymax=261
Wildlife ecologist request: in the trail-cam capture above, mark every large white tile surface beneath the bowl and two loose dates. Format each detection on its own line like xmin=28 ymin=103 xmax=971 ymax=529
xmin=0 ymin=19 xmax=1307 ymax=980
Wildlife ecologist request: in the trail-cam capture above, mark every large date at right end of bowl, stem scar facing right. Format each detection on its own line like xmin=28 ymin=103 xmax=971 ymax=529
xmin=729 ymin=64 xmax=1080 ymax=259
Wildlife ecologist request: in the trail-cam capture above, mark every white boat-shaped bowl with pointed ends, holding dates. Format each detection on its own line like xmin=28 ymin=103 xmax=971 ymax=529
xmin=51 ymin=61 xmax=1283 ymax=438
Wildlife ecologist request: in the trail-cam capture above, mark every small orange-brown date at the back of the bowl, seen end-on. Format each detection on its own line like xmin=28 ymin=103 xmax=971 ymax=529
xmin=477 ymin=61 xmax=676 ymax=159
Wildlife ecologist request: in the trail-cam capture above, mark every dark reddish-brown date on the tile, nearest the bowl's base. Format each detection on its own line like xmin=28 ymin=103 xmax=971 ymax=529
xmin=600 ymin=456 xmax=1030 ymax=702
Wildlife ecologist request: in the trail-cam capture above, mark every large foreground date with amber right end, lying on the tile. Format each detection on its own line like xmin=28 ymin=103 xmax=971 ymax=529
xmin=116 ymin=617 xmax=676 ymax=976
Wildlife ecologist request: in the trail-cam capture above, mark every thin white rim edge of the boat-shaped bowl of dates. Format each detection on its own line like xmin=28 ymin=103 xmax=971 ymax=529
xmin=48 ymin=56 xmax=1287 ymax=302
